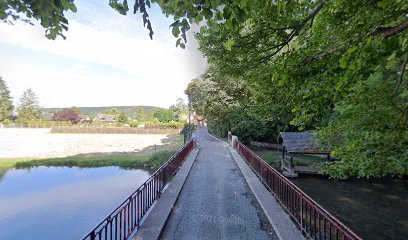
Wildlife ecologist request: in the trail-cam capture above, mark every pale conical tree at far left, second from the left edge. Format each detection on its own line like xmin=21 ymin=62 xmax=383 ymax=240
xmin=17 ymin=88 xmax=42 ymax=122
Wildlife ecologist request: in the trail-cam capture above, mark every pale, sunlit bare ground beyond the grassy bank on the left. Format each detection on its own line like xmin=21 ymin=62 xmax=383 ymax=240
xmin=0 ymin=129 xmax=181 ymax=158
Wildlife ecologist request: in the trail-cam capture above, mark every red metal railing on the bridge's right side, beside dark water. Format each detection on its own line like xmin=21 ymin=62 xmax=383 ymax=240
xmin=233 ymin=141 xmax=362 ymax=240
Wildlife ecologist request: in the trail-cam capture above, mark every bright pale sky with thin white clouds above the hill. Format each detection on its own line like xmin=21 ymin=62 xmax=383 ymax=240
xmin=0 ymin=0 xmax=206 ymax=108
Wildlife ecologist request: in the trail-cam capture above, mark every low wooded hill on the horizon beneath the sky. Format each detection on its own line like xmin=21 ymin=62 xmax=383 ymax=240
xmin=41 ymin=106 xmax=163 ymax=116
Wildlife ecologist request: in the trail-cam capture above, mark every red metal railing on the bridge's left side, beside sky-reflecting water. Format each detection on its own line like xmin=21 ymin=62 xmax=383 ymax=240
xmin=83 ymin=140 xmax=195 ymax=240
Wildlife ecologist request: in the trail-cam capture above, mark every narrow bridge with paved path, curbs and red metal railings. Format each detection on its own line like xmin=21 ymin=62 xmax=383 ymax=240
xmin=83 ymin=128 xmax=361 ymax=240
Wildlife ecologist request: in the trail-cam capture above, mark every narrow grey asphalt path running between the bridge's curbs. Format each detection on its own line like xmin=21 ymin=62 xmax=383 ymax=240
xmin=162 ymin=128 xmax=277 ymax=239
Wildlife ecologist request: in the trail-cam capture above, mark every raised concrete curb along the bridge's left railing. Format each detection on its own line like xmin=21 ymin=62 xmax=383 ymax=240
xmin=132 ymin=148 xmax=199 ymax=240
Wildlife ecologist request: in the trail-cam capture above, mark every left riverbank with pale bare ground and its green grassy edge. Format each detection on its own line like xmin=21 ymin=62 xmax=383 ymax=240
xmin=0 ymin=129 xmax=183 ymax=169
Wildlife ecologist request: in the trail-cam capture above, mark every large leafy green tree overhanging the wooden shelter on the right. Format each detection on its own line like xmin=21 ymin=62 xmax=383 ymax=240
xmin=193 ymin=1 xmax=408 ymax=178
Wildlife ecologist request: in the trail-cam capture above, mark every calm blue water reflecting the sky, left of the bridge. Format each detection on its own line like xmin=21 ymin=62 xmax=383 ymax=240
xmin=0 ymin=167 xmax=150 ymax=240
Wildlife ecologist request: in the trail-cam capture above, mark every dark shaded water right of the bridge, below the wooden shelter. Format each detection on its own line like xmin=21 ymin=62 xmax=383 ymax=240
xmin=292 ymin=176 xmax=408 ymax=239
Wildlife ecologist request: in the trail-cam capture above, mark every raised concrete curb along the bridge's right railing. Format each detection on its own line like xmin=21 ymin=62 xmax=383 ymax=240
xmin=224 ymin=142 xmax=305 ymax=240
